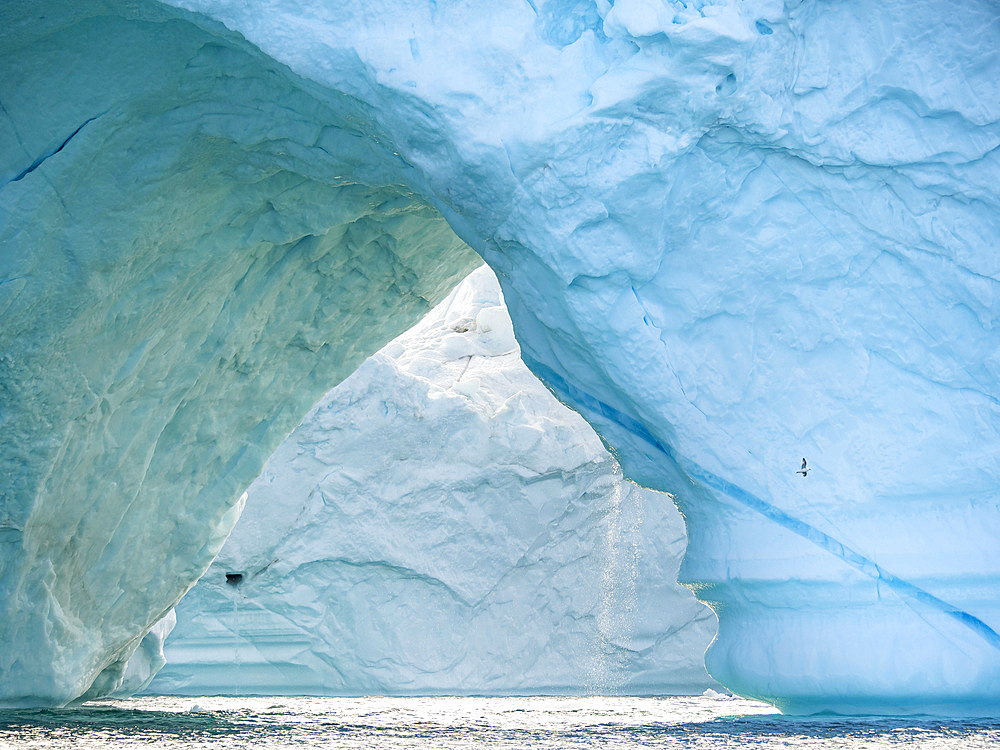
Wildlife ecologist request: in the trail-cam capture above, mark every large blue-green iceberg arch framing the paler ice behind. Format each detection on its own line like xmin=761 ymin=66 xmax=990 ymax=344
xmin=0 ymin=0 xmax=1000 ymax=712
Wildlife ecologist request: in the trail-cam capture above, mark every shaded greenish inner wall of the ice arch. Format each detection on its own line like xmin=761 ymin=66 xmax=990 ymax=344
xmin=0 ymin=1 xmax=478 ymax=704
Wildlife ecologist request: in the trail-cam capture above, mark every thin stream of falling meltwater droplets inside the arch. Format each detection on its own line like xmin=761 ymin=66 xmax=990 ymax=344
xmin=587 ymin=462 xmax=642 ymax=695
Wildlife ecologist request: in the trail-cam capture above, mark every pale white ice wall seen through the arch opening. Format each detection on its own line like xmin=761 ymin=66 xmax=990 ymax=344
xmin=148 ymin=267 xmax=718 ymax=695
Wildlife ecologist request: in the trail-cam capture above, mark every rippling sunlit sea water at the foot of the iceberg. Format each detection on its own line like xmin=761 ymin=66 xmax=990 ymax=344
xmin=0 ymin=697 xmax=1000 ymax=750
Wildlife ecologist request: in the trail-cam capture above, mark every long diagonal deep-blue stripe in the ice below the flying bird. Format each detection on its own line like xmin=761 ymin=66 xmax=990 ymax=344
xmin=522 ymin=353 xmax=1000 ymax=650
